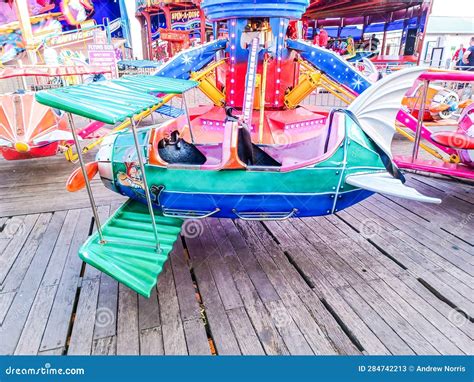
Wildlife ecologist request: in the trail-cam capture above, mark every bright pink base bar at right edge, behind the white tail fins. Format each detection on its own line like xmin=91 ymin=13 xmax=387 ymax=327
xmin=394 ymin=156 xmax=474 ymax=179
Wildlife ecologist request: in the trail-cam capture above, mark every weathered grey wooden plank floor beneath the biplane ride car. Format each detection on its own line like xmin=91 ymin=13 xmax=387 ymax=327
xmin=0 ymin=152 xmax=474 ymax=354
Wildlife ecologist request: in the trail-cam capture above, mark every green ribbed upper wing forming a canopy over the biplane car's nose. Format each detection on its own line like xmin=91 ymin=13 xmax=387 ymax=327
xmin=36 ymin=75 xmax=198 ymax=125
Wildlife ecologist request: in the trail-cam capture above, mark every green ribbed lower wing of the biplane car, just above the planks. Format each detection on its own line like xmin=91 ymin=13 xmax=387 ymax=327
xmin=79 ymin=199 xmax=183 ymax=297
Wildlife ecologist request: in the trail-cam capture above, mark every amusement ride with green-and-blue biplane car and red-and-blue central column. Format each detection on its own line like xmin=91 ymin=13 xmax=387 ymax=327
xmin=27 ymin=0 xmax=454 ymax=297
